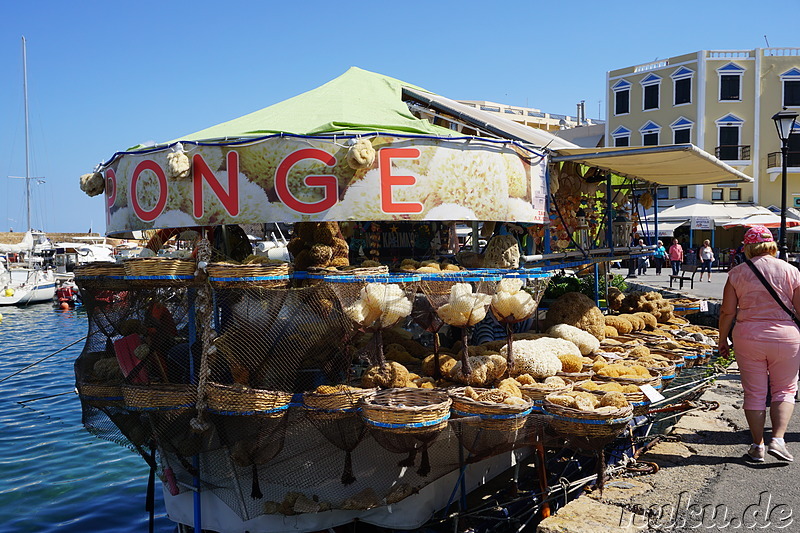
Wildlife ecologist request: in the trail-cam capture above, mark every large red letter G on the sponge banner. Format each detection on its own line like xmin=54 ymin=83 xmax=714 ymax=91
xmin=275 ymin=148 xmax=339 ymax=215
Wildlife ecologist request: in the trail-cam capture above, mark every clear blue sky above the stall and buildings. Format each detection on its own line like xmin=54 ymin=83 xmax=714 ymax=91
xmin=0 ymin=0 xmax=800 ymax=233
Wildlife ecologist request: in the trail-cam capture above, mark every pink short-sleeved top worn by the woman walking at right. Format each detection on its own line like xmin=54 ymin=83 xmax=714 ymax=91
xmin=728 ymin=255 xmax=800 ymax=342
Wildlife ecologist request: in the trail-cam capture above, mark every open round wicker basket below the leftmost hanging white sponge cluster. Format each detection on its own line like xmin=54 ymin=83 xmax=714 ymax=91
xmin=359 ymin=388 xmax=452 ymax=434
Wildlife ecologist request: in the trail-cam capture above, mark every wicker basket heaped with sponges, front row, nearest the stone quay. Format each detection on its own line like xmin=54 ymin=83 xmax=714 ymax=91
xmin=542 ymin=391 xmax=633 ymax=440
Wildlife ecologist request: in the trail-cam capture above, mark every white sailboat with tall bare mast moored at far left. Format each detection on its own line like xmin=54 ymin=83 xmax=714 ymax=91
xmin=0 ymin=37 xmax=56 ymax=305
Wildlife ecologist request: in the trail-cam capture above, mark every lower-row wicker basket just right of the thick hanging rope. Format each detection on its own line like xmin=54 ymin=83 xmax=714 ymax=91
xmin=207 ymin=383 xmax=292 ymax=418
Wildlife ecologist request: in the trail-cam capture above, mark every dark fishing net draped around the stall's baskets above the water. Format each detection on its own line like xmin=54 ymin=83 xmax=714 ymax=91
xmin=75 ymin=267 xmax=564 ymax=520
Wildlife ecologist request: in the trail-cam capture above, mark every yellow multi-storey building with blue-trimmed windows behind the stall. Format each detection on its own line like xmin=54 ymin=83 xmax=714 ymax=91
xmin=605 ymin=48 xmax=800 ymax=208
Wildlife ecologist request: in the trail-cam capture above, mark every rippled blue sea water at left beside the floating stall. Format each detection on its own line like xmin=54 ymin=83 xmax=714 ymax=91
xmin=0 ymin=304 xmax=175 ymax=533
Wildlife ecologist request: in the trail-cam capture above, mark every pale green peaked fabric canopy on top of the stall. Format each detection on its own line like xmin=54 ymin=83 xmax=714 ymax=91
xmin=173 ymin=67 xmax=458 ymax=142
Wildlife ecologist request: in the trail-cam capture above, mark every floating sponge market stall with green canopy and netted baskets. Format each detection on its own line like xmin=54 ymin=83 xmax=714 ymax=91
xmin=75 ymin=69 xmax=744 ymax=531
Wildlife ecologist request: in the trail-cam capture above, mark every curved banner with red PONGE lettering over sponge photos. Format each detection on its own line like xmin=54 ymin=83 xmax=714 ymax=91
xmin=102 ymin=136 xmax=546 ymax=234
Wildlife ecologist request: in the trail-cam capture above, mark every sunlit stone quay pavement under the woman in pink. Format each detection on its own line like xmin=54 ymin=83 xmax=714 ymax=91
xmin=537 ymin=271 xmax=800 ymax=533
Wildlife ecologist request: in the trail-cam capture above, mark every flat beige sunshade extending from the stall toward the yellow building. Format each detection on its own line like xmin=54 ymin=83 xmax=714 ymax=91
xmin=551 ymin=144 xmax=753 ymax=185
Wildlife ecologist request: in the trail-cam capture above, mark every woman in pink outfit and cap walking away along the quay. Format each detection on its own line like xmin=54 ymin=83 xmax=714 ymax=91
xmin=719 ymin=226 xmax=800 ymax=463
